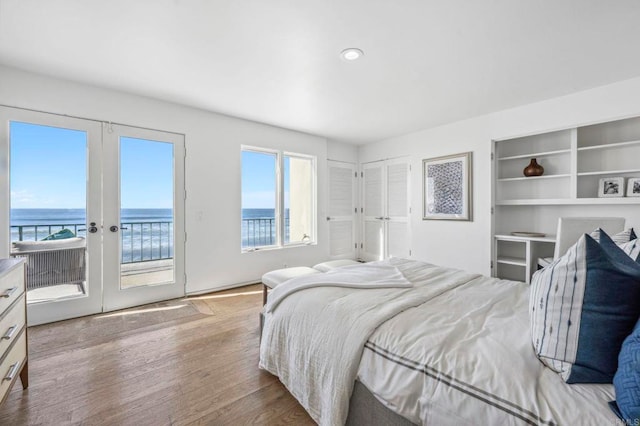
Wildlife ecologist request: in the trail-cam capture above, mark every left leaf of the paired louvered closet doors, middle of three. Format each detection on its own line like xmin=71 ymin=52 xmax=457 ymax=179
xmin=360 ymin=161 xmax=386 ymax=261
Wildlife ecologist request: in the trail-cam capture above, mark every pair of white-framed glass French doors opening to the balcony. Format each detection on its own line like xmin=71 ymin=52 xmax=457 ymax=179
xmin=0 ymin=107 xmax=184 ymax=325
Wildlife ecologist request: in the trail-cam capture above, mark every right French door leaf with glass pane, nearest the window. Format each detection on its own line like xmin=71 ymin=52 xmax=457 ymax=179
xmin=104 ymin=125 xmax=184 ymax=311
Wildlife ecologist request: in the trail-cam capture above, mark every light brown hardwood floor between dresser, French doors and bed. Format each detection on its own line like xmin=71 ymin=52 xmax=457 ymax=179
xmin=0 ymin=285 xmax=315 ymax=426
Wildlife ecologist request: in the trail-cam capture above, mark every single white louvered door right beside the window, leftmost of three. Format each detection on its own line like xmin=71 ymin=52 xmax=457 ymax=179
xmin=327 ymin=161 xmax=356 ymax=259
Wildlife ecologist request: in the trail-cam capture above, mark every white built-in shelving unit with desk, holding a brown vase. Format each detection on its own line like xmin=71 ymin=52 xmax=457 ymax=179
xmin=493 ymin=117 xmax=640 ymax=282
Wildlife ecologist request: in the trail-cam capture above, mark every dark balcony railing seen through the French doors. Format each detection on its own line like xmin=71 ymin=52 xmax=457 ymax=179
xmin=11 ymin=222 xmax=173 ymax=264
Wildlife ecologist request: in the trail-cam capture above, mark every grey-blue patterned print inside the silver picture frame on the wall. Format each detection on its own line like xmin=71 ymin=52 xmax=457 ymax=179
xmin=427 ymin=161 xmax=463 ymax=214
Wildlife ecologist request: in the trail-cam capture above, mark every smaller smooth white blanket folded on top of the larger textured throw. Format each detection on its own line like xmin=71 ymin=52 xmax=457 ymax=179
xmin=265 ymin=263 xmax=412 ymax=312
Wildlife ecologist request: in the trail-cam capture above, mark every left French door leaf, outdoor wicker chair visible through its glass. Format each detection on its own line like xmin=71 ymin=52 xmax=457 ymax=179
xmin=0 ymin=108 xmax=102 ymax=325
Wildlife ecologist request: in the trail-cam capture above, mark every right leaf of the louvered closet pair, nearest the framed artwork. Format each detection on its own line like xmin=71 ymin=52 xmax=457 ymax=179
xmin=385 ymin=159 xmax=411 ymax=257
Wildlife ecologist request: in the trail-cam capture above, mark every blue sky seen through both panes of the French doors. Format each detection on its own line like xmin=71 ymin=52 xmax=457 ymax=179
xmin=11 ymin=122 xmax=173 ymax=209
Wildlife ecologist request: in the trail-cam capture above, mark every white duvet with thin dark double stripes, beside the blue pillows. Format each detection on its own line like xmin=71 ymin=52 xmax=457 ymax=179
xmin=358 ymin=277 xmax=620 ymax=425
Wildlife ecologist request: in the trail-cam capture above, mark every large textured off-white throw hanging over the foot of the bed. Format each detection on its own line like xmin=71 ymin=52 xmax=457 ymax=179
xmin=260 ymin=259 xmax=479 ymax=426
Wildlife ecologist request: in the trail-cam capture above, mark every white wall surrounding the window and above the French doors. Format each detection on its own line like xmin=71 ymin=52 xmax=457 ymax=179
xmin=0 ymin=67 xmax=354 ymax=293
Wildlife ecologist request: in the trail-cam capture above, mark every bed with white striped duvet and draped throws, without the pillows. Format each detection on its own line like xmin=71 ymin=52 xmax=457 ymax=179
xmin=260 ymin=258 xmax=620 ymax=425
